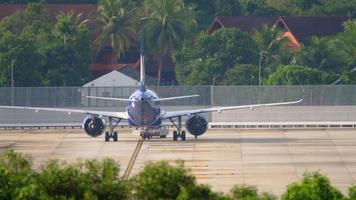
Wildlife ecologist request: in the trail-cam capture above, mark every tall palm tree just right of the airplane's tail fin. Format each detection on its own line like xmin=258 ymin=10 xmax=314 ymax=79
xmin=143 ymin=0 xmax=196 ymax=85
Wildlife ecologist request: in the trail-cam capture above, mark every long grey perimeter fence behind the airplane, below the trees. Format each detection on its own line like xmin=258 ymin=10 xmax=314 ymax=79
xmin=0 ymin=85 xmax=356 ymax=107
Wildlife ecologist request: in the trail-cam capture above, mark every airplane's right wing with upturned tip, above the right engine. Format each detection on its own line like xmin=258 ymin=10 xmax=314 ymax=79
xmin=161 ymin=99 xmax=303 ymax=119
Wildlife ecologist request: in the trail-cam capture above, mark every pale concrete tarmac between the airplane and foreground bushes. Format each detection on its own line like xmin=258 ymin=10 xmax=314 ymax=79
xmin=0 ymin=129 xmax=356 ymax=195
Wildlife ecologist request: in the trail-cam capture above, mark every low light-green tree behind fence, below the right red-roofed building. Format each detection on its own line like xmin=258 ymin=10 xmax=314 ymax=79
xmin=267 ymin=65 xmax=337 ymax=85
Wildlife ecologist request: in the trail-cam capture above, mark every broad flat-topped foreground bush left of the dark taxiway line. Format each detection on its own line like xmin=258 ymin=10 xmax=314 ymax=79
xmin=36 ymin=159 xmax=129 ymax=199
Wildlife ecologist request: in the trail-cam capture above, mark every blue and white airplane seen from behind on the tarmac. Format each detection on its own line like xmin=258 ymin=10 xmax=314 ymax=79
xmin=0 ymin=41 xmax=303 ymax=142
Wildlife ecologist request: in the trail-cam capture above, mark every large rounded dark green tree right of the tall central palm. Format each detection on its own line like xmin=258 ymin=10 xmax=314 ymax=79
xmin=174 ymin=28 xmax=258 ymax=85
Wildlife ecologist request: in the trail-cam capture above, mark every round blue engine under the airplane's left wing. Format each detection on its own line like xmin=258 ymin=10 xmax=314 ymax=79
xmin=83 ymin=116 xmax=105 ymax=137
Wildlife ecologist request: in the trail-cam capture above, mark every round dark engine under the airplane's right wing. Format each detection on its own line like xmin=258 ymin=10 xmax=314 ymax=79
xmin=185 ymin=114 xmax=208 ymax=136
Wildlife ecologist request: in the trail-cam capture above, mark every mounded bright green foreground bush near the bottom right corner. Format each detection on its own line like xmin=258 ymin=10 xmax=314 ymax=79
xmin=282 ymin=172 xmax=344 ymax=200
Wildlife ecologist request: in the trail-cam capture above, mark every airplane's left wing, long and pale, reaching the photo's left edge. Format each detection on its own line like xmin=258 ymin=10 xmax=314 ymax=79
xmin=0 ymin=106 xmax=128 ymax=119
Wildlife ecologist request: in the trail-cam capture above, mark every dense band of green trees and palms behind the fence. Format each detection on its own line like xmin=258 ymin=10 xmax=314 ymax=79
xmin=0 ymin=0 xmax=356 ymax=86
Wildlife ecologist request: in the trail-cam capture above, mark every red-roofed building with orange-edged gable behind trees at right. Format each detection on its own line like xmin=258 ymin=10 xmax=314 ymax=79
xmin=208 ymin=16 xmax=349 ymax=49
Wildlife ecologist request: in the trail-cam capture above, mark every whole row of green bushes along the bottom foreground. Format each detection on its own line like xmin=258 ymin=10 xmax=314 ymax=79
xmin=0 ymin=150 xmax=356 ymax=200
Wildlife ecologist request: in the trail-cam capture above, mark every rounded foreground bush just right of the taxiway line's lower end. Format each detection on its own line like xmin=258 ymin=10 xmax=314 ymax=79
xmin=132 ymin=161 xmax=222 ymax=200
